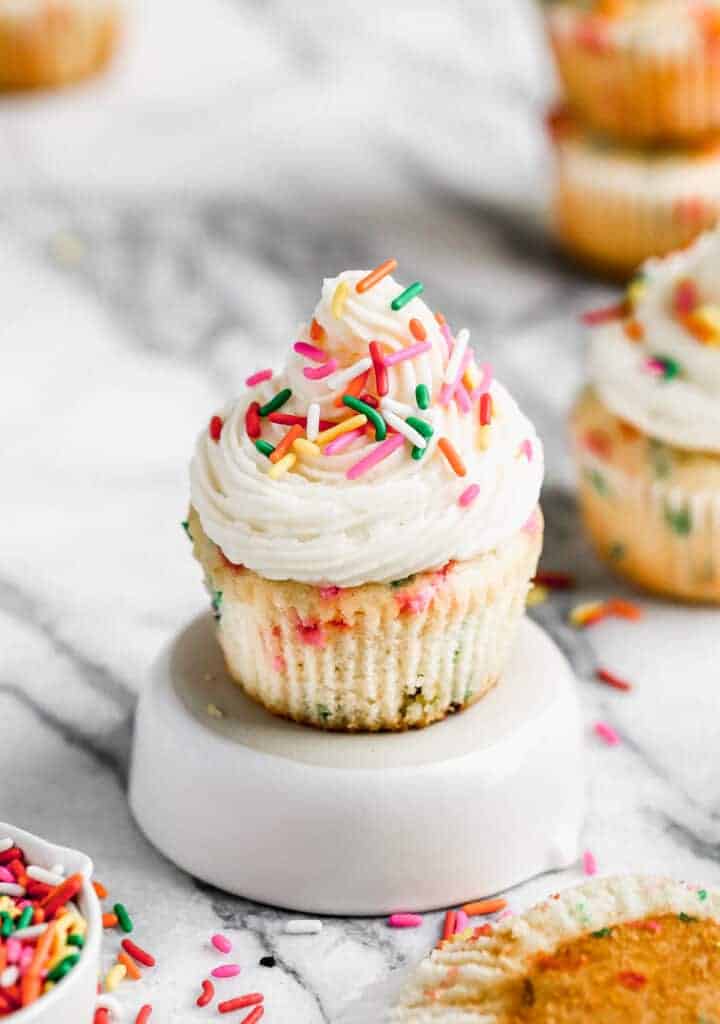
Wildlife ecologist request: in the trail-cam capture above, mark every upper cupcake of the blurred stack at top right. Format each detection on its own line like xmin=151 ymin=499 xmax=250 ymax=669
xmin=546 ymin=0 xmax=720 ymax=143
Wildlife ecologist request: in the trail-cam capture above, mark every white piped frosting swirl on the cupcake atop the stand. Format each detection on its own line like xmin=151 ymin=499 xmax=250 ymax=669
xmin=190 ymin=271 xmax=543 ymax=587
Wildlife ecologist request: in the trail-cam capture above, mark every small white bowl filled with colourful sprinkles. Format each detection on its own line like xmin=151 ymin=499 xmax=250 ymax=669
xmin=0 ymin=822 xmax=102 ymax=1024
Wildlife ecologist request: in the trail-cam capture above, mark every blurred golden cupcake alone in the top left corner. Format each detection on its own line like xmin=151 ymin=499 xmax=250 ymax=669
xmin=0 ymin=0 xmax=121 ymax=89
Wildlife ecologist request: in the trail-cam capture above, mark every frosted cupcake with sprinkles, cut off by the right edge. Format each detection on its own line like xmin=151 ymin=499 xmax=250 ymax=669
xmin=571 ymin=231 xmax=720 ymax=602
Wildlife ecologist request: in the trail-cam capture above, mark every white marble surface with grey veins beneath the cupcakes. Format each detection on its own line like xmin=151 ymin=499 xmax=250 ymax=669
xmin=0 ymin=0 xmax=720 ymax=1024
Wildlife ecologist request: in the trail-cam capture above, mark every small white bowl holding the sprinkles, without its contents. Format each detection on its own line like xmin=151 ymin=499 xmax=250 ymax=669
xmin=0 ymin=821 xmax=102 ymax=1024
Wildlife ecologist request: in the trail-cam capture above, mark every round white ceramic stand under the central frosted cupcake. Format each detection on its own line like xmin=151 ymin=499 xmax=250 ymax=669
xmin=130 ymin=616 xmax=585 ymax=914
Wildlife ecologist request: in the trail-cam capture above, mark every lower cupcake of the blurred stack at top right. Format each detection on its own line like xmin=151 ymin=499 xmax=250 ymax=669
xmin=549 ymin=110 xmax=720 ymax=276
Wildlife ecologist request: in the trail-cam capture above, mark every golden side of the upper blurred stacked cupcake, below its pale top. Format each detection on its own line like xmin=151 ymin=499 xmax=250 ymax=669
xmin=547 ymin=4 xmax=720 ymax=143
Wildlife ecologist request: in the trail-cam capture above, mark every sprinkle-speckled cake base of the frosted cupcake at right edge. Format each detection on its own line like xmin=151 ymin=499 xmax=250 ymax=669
xmin=571 ymin=390 xmax=720 ymax=604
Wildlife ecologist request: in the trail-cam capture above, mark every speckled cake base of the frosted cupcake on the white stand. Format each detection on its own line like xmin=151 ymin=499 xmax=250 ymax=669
xmin=188 ymin=510 xmax=542 ymax=731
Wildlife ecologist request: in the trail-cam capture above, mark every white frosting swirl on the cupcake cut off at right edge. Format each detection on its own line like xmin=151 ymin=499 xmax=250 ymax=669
xmin=590 ymin=231 xmax=720 ymax=452
